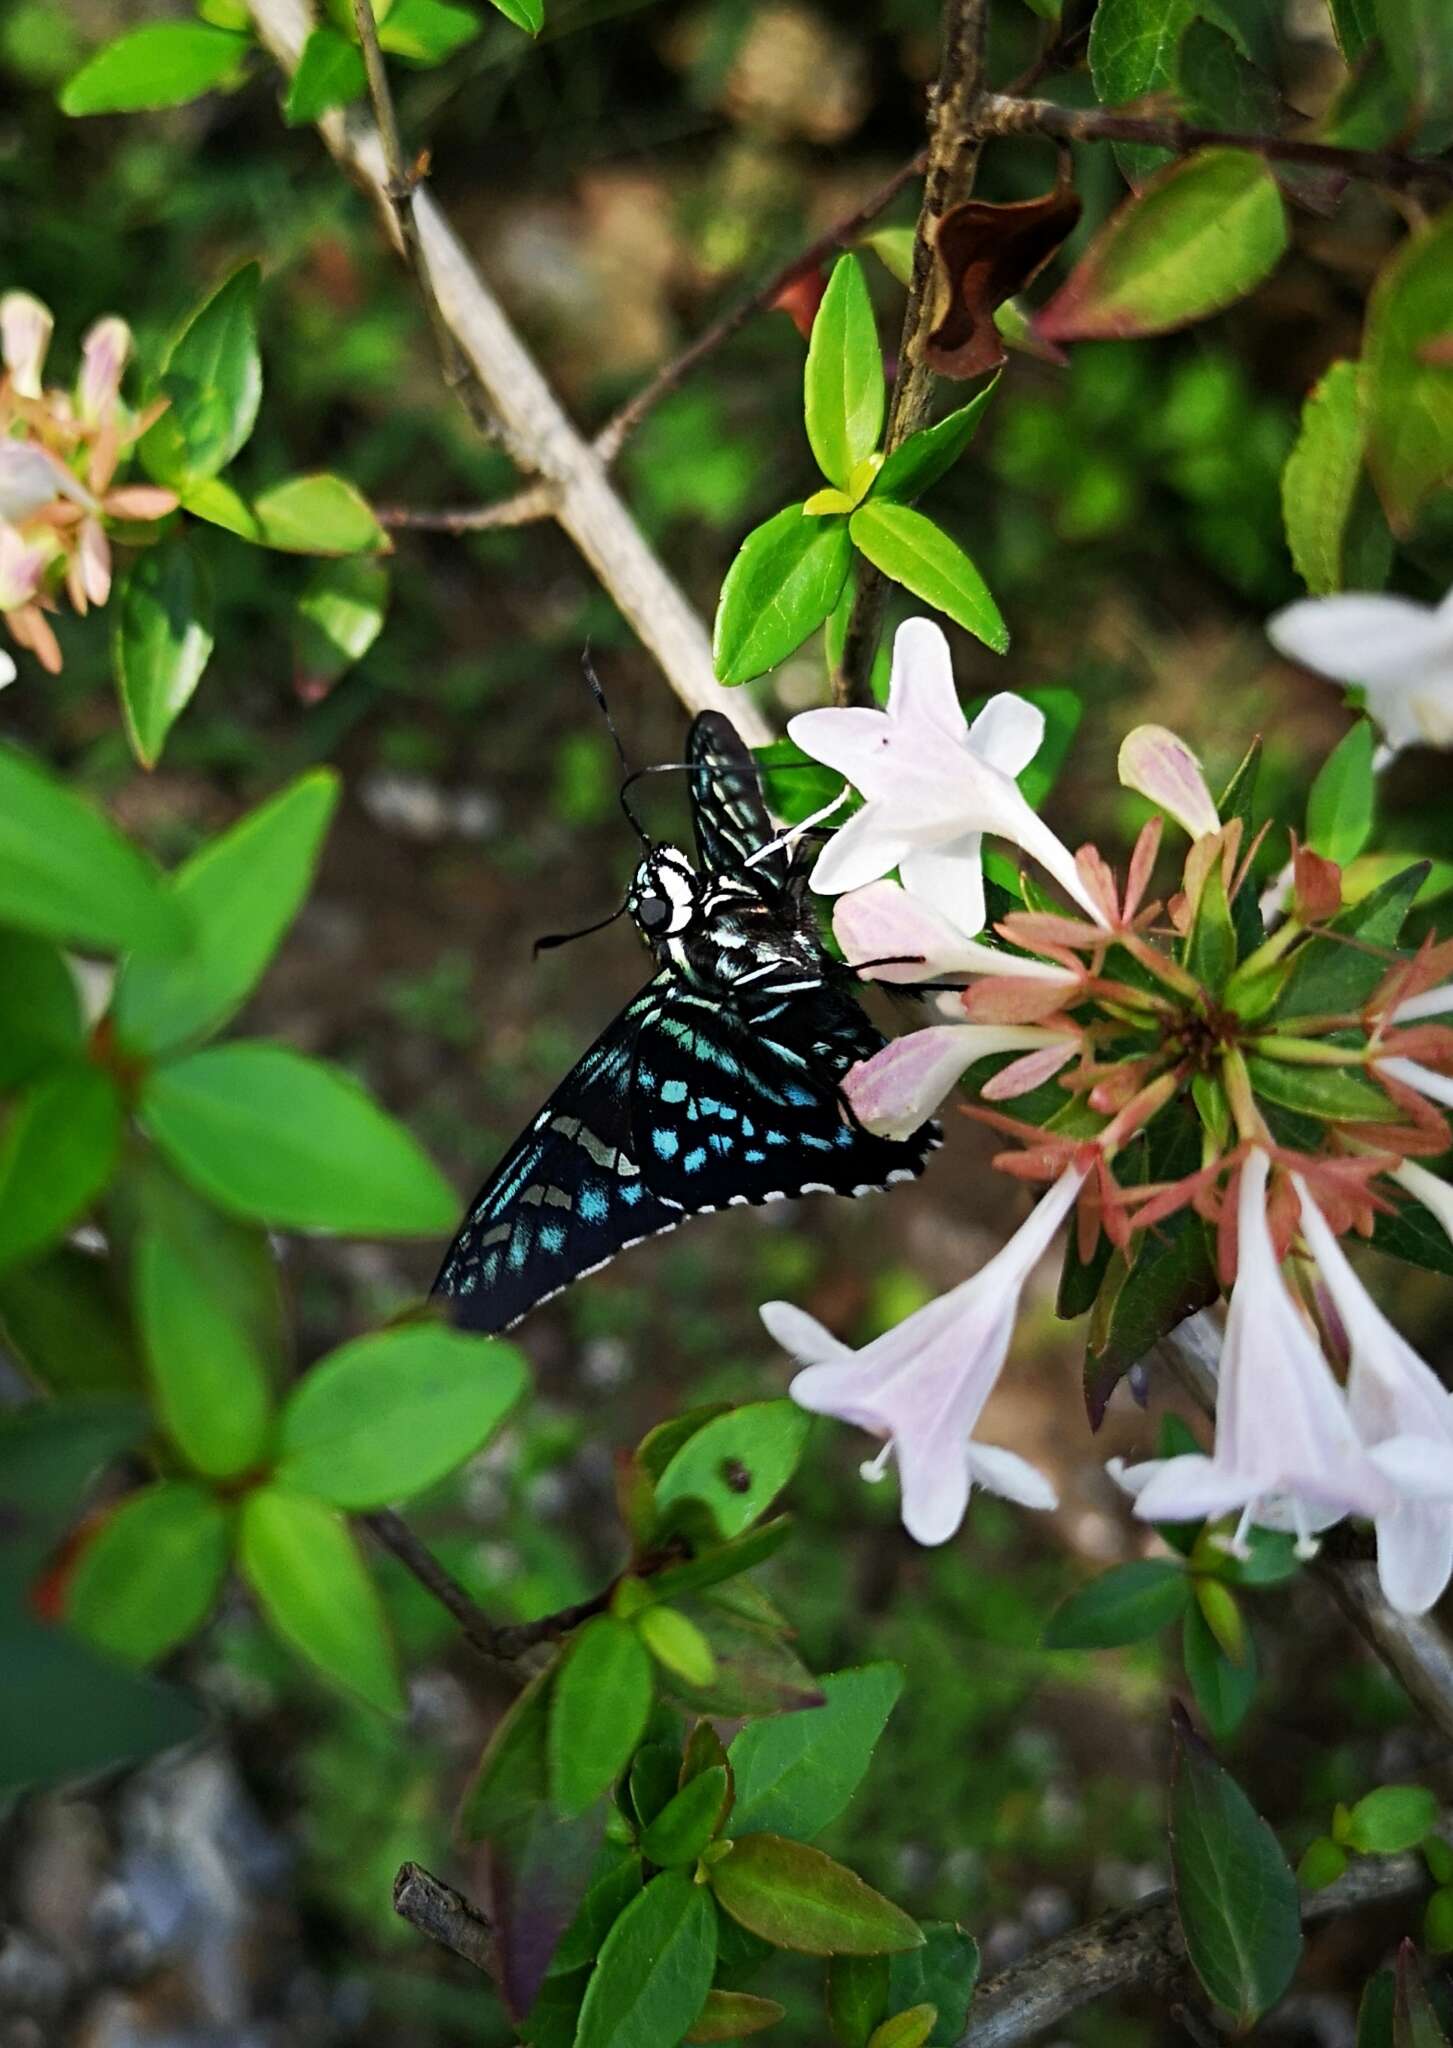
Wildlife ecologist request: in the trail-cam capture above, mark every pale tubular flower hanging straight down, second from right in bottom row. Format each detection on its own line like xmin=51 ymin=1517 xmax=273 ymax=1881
xmin=1117 ymin=1151 xmax=1396 ymax=1554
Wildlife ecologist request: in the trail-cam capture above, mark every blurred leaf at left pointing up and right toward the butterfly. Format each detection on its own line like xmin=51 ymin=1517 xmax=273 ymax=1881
xmin=111 ymin=768 xmax=338 ymax=1055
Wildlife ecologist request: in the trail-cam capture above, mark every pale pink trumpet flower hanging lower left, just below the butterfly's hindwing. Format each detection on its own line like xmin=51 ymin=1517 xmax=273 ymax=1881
xmin=760 ymin=1167 xmax=1084 ymax=1544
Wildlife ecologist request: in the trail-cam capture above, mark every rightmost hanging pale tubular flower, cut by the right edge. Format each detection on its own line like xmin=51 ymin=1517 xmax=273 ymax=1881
xmin=1291 ymin=1174 xmax=1453 ymax=1614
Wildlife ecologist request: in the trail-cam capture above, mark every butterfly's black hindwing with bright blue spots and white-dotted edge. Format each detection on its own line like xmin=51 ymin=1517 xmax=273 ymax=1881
xmin=631 ymin=981 xmax=941 ymax=1214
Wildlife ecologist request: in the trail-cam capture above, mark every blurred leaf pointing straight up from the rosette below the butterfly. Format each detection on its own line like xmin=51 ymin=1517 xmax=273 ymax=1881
xmin=133 ymin=1229 xmax=273 ymax=1479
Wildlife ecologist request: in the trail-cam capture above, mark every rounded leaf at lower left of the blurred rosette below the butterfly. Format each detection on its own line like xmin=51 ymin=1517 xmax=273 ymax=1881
xmin=66 ymin=1479 xmax=232 ymax=1665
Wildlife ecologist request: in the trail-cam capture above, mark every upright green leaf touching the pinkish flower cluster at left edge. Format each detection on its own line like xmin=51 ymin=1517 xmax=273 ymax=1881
xmin=139 ymin=262 xmax=262 ymax=494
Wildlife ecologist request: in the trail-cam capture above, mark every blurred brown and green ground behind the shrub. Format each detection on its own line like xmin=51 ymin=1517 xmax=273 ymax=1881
xmin=0 ymin=0 xmax=1453 ymax=2048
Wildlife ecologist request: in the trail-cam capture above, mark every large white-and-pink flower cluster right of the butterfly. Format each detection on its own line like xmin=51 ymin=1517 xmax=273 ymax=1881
xmin=762 ymin=621 xmax=1453 ymax=1612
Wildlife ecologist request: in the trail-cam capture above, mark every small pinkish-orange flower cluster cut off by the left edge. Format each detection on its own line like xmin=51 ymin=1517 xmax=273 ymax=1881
xmin=0 ymin=291 xmax=176 ymax=682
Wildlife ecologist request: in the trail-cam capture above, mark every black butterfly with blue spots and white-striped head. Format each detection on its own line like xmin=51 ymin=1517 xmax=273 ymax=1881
xmin=432 ymin=711 xmax=939 ymax=1331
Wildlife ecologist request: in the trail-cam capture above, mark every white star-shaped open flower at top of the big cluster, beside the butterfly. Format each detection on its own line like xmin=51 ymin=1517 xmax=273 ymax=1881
xmin=787 ymin=618 xmax=1098 ymax=934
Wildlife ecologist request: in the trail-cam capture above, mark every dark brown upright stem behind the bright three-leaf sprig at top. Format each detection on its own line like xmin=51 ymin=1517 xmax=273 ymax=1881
xmin=832 ymin=0 xmax=988 ymax=705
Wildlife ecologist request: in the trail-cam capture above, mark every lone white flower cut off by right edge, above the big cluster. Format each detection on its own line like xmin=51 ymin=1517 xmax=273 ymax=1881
xmin=1267 ymin=590 xmax=1453 ymax=748
